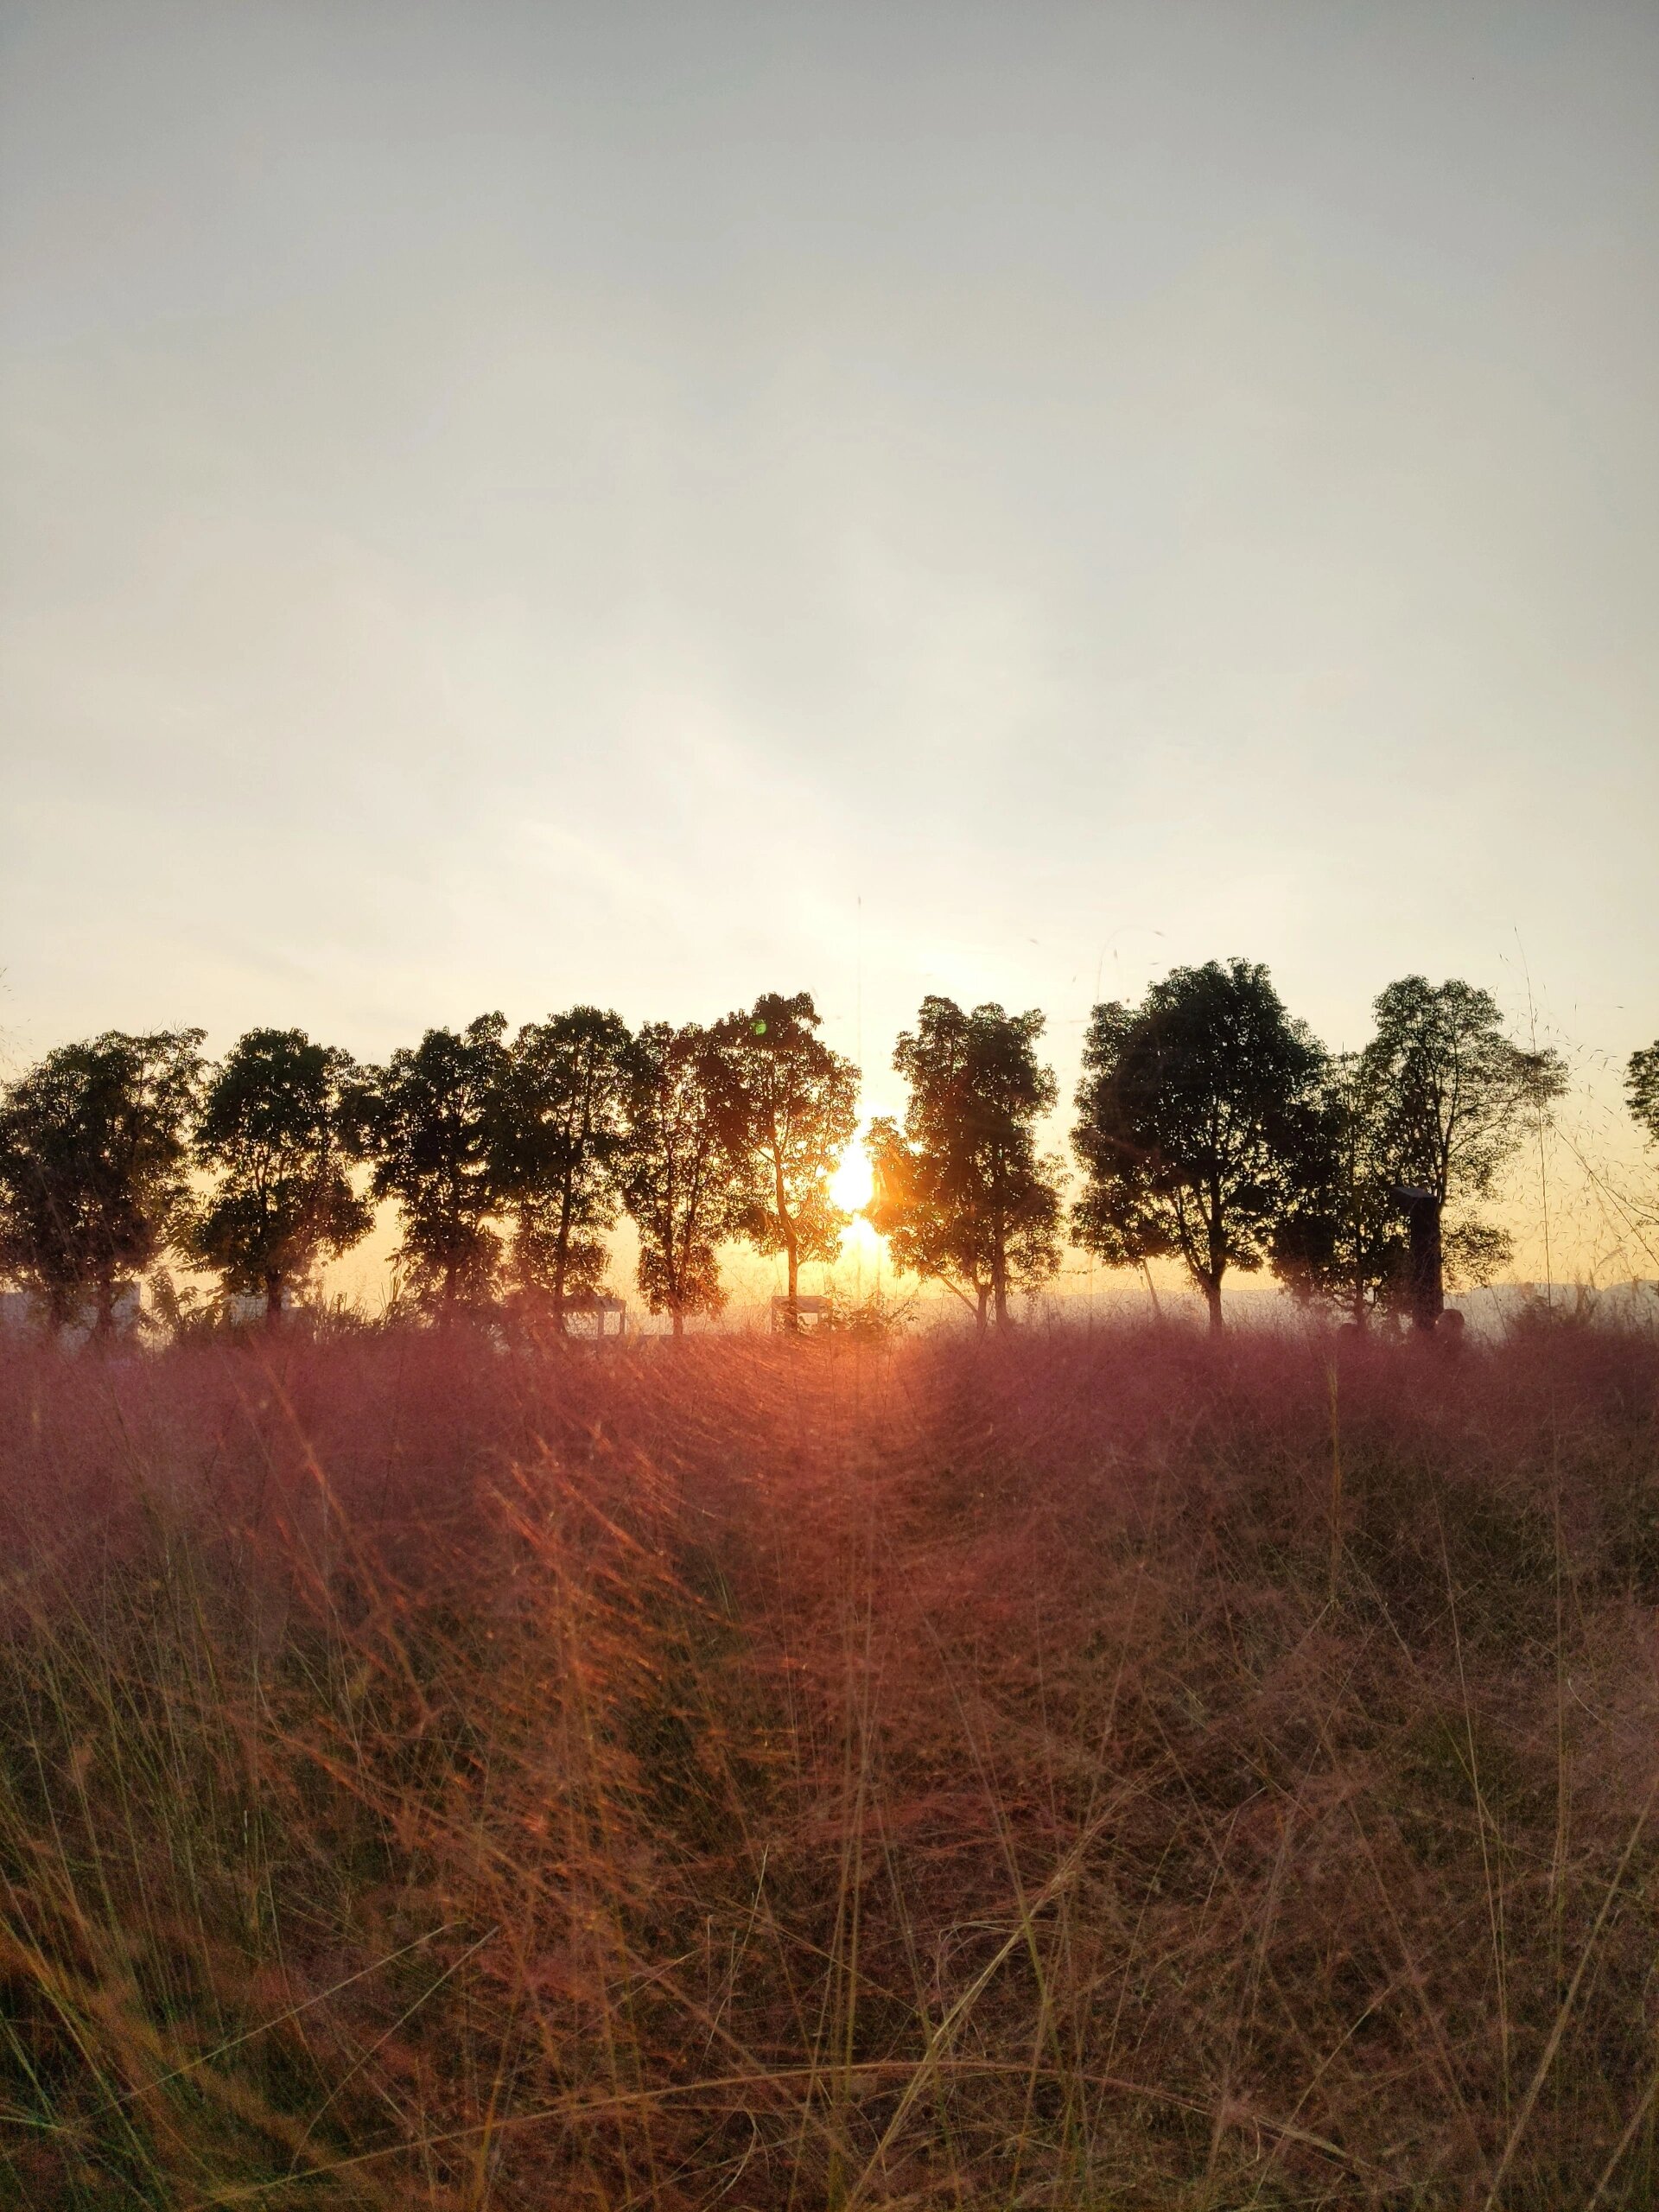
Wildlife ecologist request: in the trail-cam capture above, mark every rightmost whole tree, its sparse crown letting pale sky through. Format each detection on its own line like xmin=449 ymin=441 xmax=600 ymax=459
xmin=1360 ymin=976 xmax=1566 ymax=1327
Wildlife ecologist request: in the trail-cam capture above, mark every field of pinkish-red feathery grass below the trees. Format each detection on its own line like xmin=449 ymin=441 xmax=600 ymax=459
xmin=0 ymin=1327 xmax=1659 ymax=2212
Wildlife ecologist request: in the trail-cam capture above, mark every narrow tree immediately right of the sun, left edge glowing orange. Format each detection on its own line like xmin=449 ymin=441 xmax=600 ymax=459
xmin=865 ymin=998 xmax=1059 ymax=1330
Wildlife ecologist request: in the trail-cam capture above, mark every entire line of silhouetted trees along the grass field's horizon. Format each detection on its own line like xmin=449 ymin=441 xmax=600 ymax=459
xmin=0 ymin=960 xmax=1659 ymax=1334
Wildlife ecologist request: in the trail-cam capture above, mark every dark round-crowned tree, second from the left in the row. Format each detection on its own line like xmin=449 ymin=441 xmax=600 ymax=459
xmin=188 ymin=1028 xmax=374 ymax=1327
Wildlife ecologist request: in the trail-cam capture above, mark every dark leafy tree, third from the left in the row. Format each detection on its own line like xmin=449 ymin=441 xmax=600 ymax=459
xmin=349 ymin=1013 xmax=506 ymax=1320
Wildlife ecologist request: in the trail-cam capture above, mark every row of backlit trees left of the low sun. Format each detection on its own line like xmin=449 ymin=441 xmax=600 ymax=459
xmin=0 ymin=993 xmax=858 ymax=1334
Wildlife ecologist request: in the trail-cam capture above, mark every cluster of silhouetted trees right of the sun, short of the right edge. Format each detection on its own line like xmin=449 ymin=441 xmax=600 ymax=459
xmin=868 ymin=960 xmax=1583 ymax=1327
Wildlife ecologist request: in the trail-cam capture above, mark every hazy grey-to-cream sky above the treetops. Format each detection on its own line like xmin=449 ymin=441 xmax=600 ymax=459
xmin=0 ymin=0 xmax=1659 ymax=1247
